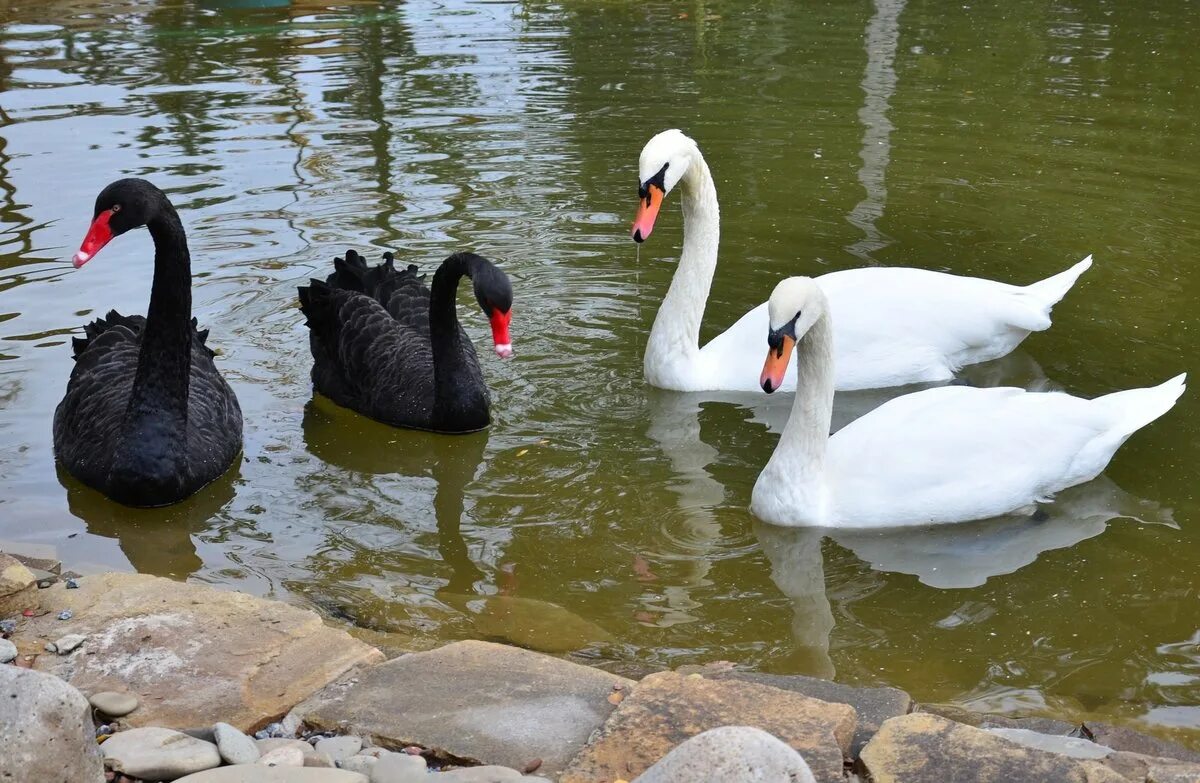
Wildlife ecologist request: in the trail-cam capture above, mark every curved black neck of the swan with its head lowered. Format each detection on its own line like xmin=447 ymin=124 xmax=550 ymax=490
xmin=430 ymin=253 xmax=488 ymax=429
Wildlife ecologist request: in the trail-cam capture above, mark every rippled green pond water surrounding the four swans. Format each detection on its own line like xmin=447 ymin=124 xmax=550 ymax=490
xmin=0 ymin=0 xmax=1200 ymax=746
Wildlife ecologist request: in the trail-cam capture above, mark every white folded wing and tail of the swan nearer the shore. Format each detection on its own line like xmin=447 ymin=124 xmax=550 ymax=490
xmin=826 ymin=376 xmax=1183 ymax=527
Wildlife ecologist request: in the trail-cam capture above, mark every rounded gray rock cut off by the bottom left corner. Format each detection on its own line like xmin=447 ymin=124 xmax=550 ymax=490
xmin=0 ymin=667 xmax=104 ymax=783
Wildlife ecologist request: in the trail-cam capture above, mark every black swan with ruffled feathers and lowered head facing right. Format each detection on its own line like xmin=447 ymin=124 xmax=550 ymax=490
xmin=300 ymin=250 xmax=512 ymax=432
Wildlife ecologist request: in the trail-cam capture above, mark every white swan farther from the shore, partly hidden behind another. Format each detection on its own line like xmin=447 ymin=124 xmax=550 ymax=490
xmin=632 ymin=130 xmax=1092 ymax=392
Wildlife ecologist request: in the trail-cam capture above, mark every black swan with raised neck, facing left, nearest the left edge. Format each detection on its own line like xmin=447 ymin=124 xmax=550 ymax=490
xmin=54 ymin=179 xmax=241 ymax=507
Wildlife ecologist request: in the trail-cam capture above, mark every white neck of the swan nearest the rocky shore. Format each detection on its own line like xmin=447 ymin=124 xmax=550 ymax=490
xmin=750 ymin=315 xmax=834 ymax=525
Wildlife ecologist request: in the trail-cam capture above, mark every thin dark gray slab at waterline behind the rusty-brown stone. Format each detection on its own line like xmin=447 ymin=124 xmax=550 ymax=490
xmin=678 ymin=663 xmax=914 ymax=758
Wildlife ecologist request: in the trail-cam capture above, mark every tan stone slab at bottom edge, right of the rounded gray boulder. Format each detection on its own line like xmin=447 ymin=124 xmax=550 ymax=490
xmin=859 ymin=712 xmax=1128 ymax=783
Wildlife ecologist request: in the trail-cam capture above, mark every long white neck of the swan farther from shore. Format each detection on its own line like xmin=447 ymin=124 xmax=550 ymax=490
xmin=643 ymin=150 xmax=721 ymax=388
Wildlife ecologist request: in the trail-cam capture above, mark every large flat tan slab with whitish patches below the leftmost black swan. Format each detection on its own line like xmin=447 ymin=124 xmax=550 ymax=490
xmin=13 ymin=573 xmax=383 ymax=731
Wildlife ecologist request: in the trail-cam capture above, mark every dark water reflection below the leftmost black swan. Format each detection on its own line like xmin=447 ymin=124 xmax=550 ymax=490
xmin=58 ymin=461 xmax=240 ymax=579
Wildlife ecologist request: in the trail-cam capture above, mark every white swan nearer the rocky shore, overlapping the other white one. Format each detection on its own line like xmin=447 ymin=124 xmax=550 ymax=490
xmin=750 ymin=277 xmax=1186 ymax=527
